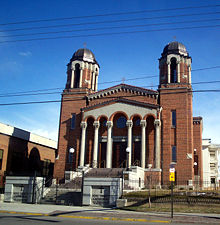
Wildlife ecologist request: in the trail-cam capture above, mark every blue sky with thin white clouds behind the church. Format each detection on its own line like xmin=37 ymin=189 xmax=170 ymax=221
xmin=0 ymin=0 xmax=220 ymax=143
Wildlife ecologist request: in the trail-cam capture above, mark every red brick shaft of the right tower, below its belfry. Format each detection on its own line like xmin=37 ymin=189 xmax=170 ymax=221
xmin=160 ymin=84 xmax=193 ymax=184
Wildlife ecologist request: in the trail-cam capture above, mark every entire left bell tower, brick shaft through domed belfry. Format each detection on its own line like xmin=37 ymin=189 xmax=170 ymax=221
xmin=54 ymin=48 xmax=99 ymax=181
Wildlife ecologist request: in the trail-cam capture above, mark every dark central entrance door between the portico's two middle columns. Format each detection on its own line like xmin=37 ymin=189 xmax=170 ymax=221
xmin=112 ymin=142 xmax=127 ymax=168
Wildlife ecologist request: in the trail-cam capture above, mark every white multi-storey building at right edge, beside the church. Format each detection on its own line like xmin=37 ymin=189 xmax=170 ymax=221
xmin=202 ymin=139 xmax=220 ymax=187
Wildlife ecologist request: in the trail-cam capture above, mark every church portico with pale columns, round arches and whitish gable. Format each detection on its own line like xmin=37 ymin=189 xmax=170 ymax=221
xmin=80 ymin=98 xmax=160 ymax=169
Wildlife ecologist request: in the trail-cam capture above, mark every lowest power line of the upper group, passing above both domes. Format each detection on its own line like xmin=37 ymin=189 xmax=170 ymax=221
xmin=0 ymin=24 xmax=220 ymax=44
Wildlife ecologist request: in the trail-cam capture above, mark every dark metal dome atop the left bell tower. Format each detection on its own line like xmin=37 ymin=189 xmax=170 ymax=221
xmin=70 ymin=48 xmax=98 ymax=64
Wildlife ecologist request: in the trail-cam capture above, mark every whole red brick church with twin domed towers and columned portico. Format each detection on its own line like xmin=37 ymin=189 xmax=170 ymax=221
xmin=54 ymin=41 xmax=202 ymax=185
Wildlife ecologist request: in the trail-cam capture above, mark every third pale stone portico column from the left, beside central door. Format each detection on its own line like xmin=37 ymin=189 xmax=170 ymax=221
xmin=106 ymin=121 xmax=113 ymax=168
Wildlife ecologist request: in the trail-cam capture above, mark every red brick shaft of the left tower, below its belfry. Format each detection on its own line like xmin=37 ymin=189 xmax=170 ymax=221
xmin=54 ymin=88 xmax=89 ymax=179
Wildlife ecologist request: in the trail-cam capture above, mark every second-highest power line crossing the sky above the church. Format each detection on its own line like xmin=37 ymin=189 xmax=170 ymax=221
xmin=0 ymin=11 xmax=220 ymax=32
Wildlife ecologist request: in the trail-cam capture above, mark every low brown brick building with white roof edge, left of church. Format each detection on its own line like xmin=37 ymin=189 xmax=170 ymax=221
xmin=0 ymin=123 xmax=57 ymax=187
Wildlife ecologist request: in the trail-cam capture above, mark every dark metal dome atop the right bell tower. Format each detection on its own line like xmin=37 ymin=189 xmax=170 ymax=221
xmin=162 ymin=41 xmax=189 ymax=56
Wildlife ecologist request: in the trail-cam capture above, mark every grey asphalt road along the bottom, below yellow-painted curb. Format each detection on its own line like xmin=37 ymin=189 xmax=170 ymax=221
xmin=0 ymin=213 xmax=172 ymax=225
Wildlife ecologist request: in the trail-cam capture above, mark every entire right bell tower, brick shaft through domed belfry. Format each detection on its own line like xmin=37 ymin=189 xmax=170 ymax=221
xmin=158 ymin=41 xmax=194 ymax=185
